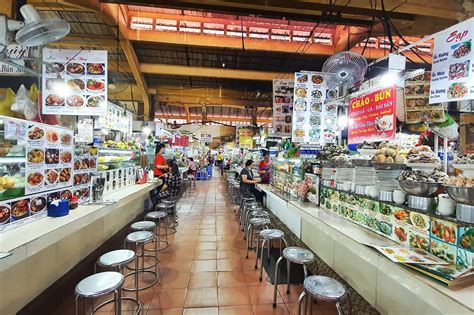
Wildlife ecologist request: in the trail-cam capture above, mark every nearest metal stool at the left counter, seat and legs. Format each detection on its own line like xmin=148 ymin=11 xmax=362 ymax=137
xmin=75 ymin=271 xmax=124 ymax=315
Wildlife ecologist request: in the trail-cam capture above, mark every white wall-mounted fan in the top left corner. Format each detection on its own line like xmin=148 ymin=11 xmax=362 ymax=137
xmin=0 ymin=4 xmax=70 ymax=47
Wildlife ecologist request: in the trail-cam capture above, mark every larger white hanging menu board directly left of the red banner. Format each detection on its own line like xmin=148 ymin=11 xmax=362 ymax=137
xmin=292 ymin=72 xmax=339 ymax=145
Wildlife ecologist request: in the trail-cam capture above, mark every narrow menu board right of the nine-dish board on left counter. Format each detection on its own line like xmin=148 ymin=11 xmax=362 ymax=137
xmin=72 ymin=145 xmax=98 ymax=203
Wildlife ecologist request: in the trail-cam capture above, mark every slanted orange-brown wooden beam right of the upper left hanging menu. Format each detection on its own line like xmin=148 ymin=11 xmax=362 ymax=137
xmin=101 ymin=4 xmax=152 ymax=120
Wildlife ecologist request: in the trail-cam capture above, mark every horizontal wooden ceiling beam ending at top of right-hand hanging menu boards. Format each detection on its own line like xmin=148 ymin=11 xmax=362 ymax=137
xmin=140 ymin=63 xmax=293 ymax=81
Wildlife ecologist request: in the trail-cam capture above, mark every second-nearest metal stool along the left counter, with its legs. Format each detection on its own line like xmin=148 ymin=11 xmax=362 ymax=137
xmin=94 ymin=249 xmax=141 ymax=314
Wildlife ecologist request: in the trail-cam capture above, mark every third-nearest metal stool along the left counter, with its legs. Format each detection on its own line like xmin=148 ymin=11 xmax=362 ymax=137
xmin=124 ymin=231 xmax=160 ymax=291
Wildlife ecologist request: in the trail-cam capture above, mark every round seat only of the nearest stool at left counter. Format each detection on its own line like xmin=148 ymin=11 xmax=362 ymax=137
xmin=76 ymin=271 xmax=124 ymax=297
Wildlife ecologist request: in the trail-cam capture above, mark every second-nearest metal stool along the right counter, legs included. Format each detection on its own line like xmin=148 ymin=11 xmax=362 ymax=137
xmin=273 ymin=247 xmax=314 ymax=307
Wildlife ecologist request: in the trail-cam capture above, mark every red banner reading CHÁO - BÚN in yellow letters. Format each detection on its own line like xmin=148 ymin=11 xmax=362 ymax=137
xmin=348 ymin=86 xmax=397 ymax=144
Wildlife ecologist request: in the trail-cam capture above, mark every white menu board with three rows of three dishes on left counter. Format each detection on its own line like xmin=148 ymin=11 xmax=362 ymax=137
xmin=25 ymin=123 xmax=73 ymax=195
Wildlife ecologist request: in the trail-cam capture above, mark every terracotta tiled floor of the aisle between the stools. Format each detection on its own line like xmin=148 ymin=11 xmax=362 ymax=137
xmin=54 ymin=176 xmax=336 ymax=315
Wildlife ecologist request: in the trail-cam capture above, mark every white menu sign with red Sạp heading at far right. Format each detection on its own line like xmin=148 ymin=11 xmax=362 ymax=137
xmin=429 ymin=18 xmax=474 ymax=104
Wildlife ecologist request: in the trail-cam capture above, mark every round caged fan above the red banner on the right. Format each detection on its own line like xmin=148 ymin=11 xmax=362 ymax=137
xmin=322 ymin=51 xmax=367 ymax=88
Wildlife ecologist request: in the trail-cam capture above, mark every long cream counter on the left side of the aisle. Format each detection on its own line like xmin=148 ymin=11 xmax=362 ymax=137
xmin=0 ymin=181 xmax=158 ymax=314
